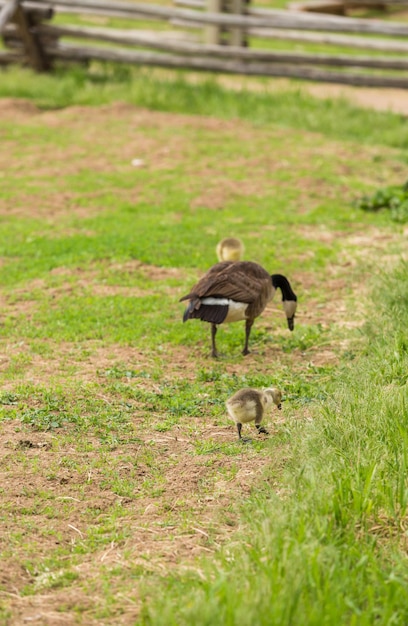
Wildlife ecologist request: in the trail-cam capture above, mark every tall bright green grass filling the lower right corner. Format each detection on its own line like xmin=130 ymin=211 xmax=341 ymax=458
xmin=140 ymin=264 xmax=408 ymax=626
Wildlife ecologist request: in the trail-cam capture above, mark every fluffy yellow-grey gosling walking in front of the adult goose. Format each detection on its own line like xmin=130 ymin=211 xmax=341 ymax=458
xmin=226 ymin=387 xmax=282 ymax=441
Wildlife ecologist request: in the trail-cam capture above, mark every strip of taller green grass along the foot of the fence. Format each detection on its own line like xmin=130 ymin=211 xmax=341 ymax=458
xmin=0 ymin=63 xmax=408 ymax=148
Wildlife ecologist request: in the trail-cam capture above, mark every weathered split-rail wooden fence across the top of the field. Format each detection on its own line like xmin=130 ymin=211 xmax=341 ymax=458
xmin=0 ymin=0 xmax=408 ymax=88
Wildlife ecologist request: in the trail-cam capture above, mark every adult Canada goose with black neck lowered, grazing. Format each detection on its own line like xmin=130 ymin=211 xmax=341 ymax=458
xmin=180 ymin=261 xmax=297 ymax=357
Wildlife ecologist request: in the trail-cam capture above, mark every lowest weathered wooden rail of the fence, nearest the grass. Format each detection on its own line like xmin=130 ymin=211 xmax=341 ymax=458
xmin=47 ymin=45 xmax=408 ymax=89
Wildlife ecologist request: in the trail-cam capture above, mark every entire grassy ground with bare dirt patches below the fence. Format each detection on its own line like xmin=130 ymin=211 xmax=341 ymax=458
xmin=0 ymin=53 xmax=408 ymax=626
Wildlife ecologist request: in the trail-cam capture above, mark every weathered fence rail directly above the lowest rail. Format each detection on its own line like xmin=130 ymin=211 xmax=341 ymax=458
xmin=37 ymin=24 xmax=408 ymax=70
